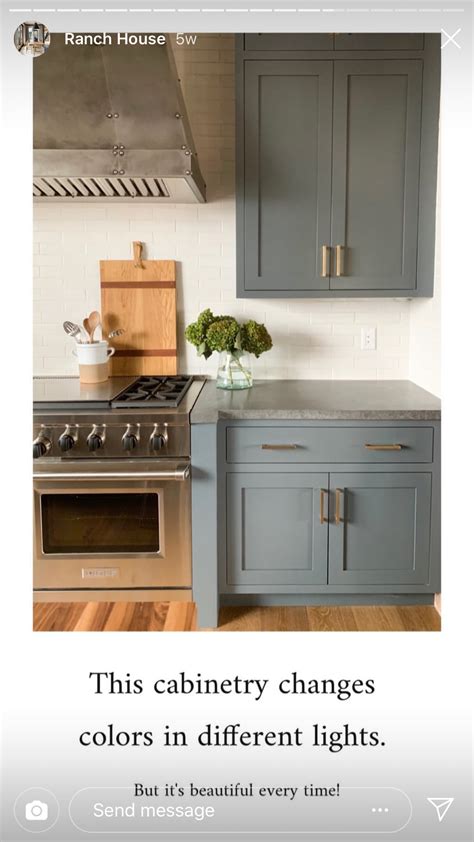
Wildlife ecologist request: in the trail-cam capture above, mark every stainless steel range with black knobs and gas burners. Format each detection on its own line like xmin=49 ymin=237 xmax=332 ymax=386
xmin=33 ymin=376 xmax=203 ymax=601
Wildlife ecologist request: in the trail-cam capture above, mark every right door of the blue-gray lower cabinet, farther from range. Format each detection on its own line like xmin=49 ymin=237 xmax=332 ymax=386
xmin=329 ymin=473 xmax=431 ymax=586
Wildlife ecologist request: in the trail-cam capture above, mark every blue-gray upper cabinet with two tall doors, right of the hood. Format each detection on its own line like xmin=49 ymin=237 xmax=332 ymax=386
xmin=236 ymin=34 xmax=440 ymax=298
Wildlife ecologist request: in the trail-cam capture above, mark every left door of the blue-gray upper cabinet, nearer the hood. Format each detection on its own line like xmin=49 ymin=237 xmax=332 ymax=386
xmin=243 ymin=60 xmax=333 ymax=297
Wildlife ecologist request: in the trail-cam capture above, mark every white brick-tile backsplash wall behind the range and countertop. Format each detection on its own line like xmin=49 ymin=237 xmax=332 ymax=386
xmin=34 ymin=35 xmax=437 ymax=385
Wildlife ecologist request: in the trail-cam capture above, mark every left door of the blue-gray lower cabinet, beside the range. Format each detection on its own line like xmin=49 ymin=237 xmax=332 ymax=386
xmin=227 ymin=473 xmax=328 ymax=586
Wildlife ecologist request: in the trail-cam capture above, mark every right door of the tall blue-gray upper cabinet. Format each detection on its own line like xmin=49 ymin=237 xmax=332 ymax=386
xmin=331 ymin=59 xmax=423 ymax=292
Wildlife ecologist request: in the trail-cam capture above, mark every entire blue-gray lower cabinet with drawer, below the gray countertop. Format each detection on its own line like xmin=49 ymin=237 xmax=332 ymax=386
xmin=191 ymin=418 xmax=441 ymax=627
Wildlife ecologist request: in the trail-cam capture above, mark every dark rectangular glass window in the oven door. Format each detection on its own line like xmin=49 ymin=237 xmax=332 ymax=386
xmin=41 ymin=493 xmax=160 ymax=554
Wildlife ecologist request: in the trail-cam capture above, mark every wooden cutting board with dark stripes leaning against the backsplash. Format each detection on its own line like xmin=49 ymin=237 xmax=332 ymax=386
xmin=100 ymin=242 xmax=178 ymax=375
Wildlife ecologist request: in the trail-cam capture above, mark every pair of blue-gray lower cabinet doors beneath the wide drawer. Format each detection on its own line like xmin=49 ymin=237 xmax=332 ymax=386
xmin=226 ymin=470 xmax=432 ymax=592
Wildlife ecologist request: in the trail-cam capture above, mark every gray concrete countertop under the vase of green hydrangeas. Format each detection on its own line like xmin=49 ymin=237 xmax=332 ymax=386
xmin=191 ymin=380 xmax=441 ymax=424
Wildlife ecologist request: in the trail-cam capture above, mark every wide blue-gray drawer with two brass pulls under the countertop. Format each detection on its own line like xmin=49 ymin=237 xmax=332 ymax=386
xmin=227 ymin=426 xmax=433 ymax=465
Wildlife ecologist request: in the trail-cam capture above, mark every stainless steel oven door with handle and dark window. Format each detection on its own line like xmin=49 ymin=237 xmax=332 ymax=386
xmin=34 ymin=460 xmax=191 ymax=591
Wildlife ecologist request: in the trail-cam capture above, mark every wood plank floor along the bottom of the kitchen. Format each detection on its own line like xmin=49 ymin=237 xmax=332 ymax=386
xmin=33 ymin=602 xmax=441 ymax=632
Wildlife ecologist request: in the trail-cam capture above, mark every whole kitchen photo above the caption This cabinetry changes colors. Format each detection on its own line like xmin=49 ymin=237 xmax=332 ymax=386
xmin=32 ymin=29 xmax=441 ymax=632
